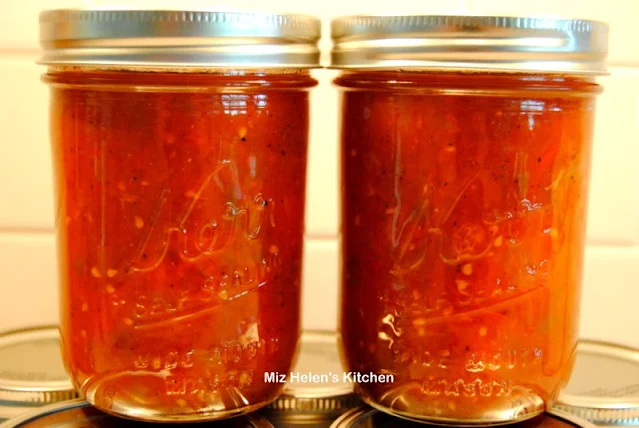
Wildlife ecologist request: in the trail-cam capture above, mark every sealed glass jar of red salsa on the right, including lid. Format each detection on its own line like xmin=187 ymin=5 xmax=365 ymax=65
xmin=332 ymin=16 xmax=607 ymax=425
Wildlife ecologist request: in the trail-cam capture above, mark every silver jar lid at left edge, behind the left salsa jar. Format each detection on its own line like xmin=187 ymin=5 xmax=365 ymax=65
xmin=0 ymin=326 xmax=77 ymax=419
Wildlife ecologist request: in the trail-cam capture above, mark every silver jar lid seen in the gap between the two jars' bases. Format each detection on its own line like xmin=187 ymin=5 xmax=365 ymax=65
xmin=265 ymin=332 xmax=361 ymax=427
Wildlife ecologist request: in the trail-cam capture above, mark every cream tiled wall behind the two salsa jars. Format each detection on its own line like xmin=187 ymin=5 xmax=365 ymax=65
xmin=0 ymin=0 xmax=639 ymax=347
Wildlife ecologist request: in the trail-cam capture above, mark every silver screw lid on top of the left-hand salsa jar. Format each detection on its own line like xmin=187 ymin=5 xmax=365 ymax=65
xmin=39 ymin=9 xmax=321 ymax=68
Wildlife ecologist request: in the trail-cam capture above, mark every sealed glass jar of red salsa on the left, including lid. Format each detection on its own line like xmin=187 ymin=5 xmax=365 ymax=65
xmin=41 ymin=11 xmax=320 ymax=421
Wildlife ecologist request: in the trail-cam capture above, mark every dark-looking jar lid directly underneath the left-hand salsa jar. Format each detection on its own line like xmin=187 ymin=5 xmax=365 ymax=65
xmin=0 ymin=400 xmax=274 ymax=428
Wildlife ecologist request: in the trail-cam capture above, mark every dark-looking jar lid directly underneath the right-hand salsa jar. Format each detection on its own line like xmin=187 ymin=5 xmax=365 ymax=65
xmin=332 ymin=406 xmax=595 ymax=428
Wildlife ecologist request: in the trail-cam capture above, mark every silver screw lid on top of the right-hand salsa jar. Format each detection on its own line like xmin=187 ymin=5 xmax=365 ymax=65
xmin=331 ymin=15 xmax=608 ymax=75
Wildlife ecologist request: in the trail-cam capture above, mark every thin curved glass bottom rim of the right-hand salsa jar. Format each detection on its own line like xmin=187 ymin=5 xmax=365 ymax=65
xmin=360 ymin=393 xmax=546 ymax=427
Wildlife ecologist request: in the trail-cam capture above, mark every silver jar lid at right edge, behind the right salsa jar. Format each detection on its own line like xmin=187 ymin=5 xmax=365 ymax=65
xmin=555 ymin=340 xmax=639 ymax=425
